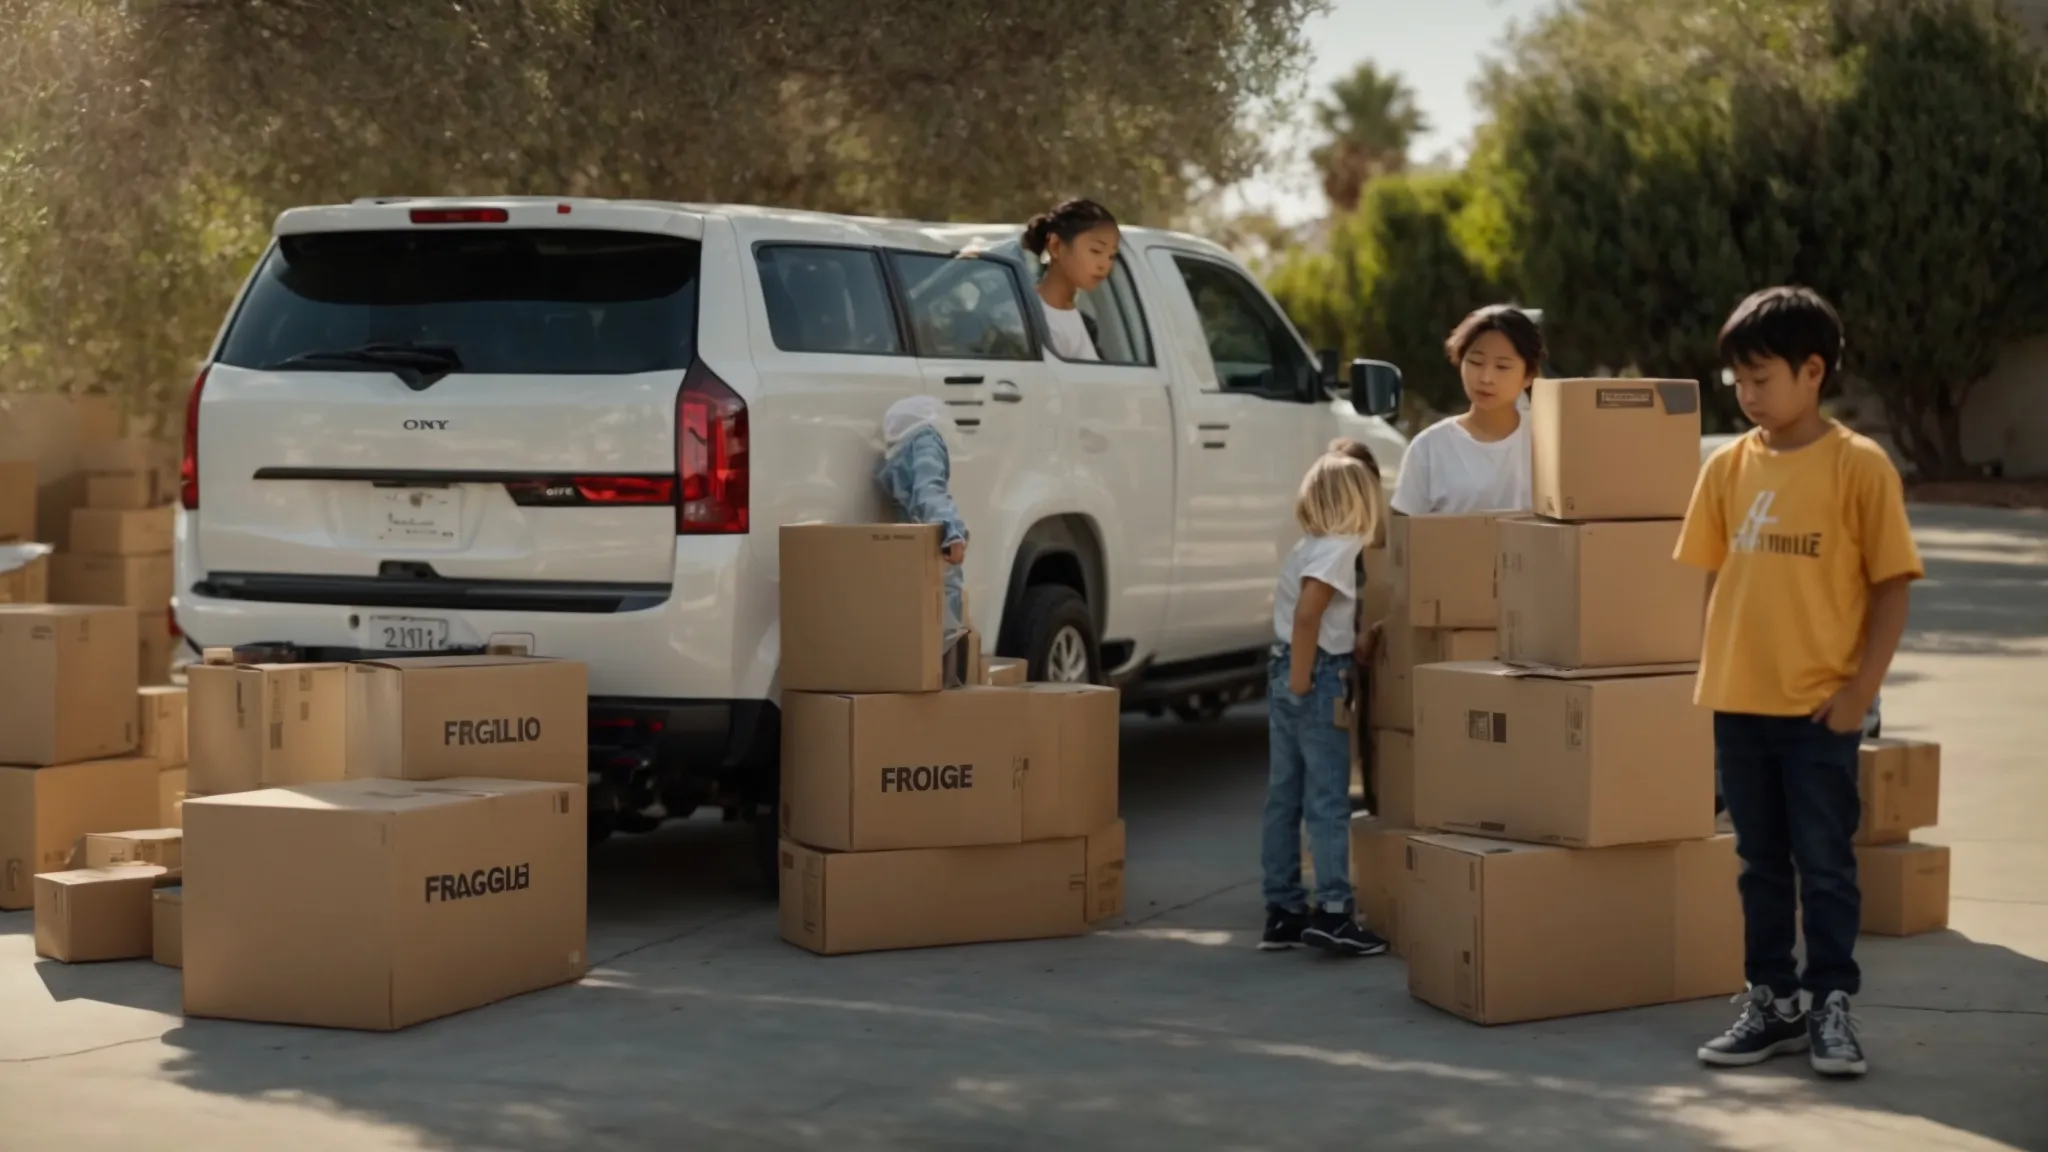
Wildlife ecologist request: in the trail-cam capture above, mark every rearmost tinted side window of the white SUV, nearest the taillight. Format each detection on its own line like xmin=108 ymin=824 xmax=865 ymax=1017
xmin=754 ymin=244 xmax=903 ymax=357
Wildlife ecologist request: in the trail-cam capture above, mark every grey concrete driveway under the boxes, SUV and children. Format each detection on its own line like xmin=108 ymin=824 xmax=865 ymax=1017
xmin=0 ymin=508 xmax=2048 ymax=1152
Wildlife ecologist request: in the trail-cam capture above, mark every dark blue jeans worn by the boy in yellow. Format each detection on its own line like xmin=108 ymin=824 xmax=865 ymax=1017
xmin=1714 ymin=711 xmax=1864 ymax=1000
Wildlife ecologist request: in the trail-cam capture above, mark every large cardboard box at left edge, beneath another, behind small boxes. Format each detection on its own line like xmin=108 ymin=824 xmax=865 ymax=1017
xmin=0 ymin=758 xmax=158 ymax=912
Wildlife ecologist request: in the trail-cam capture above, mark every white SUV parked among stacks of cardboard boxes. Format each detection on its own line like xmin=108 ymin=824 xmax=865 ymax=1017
xmin=174 ymin=199 xmax=1405 ymax=832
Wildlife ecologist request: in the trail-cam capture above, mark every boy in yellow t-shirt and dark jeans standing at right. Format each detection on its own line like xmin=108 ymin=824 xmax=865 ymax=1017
xmin=1677 ymin=287 xmax=1923 ymax=1076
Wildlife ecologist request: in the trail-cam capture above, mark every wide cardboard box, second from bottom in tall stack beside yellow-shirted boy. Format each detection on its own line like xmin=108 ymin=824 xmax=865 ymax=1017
xmin=1415 ymin=662 xmax=1714 ymax=849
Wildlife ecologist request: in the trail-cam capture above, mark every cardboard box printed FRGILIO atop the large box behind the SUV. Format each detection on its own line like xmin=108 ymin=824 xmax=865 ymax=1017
xmin=344 ymin=656 xmax=590 ymax=778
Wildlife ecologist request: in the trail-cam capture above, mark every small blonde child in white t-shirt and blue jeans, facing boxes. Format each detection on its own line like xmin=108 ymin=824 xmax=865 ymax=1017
xmin=1260 ymin=453 xmax=1386 ymax=955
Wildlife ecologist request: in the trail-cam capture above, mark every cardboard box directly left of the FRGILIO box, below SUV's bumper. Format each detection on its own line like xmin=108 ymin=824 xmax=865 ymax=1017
xmin=184 ymin=664 xmax=350 ymax=795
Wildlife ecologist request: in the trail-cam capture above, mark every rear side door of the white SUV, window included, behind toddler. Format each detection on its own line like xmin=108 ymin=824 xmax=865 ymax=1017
xmin=889 ymin=250 xmax=1061 ymax=640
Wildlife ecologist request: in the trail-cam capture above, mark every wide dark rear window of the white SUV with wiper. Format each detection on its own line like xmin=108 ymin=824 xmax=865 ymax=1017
xmin=219 ymin=228 xmax=700 ymax=375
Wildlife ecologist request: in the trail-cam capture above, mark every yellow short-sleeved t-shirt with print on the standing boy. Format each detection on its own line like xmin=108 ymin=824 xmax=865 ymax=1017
xmin=1677 ymin=424 xmax=1925 ymax=715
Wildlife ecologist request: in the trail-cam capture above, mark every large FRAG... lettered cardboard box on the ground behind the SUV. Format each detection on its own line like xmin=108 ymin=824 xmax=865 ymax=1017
xmin=184 ymin=779 xmax=588 ymax=1031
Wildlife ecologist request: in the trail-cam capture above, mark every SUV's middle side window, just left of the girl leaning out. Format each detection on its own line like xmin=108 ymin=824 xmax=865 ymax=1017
xmin=889 ymin=252 xmax=1034 ymax=361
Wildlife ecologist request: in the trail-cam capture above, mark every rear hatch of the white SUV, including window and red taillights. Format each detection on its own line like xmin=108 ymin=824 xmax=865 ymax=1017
xmin=186 ymin=201 xmax=745 ymax=611
